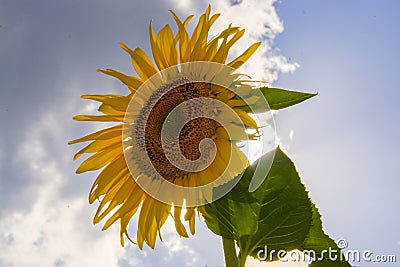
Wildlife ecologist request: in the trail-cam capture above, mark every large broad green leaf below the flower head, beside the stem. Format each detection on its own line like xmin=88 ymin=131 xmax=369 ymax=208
xmin=201 ymin=147 xmax=349 ymax=267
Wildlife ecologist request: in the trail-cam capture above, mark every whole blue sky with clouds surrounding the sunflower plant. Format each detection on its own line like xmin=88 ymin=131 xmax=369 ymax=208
xmin=0 ymin=0 xmax=400 ymax=267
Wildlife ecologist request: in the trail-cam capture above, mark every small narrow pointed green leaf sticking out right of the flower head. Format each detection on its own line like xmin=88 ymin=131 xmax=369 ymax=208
xmin=238 ymin=87 xmax=317 ymax=113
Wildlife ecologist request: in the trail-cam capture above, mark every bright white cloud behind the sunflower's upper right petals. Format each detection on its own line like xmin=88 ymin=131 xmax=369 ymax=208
xmin=170 ymin=0 xmax=299 ymax=83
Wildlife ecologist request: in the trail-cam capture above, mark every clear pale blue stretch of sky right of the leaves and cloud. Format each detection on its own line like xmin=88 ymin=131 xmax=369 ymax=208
xmin=275 ymin=1 xmax=400 ymax=260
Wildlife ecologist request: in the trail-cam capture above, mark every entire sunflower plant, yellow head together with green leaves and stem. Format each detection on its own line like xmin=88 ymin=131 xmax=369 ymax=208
xmin=70 ymin=6 xmax=349 ymax=267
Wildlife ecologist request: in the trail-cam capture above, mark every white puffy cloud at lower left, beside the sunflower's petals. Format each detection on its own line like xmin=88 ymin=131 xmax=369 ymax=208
xmin=0 ymin=113 xmax=124 ymax=267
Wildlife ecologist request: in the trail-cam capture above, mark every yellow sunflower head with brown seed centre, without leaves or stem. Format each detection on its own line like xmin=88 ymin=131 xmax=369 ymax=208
xmin=69 ymin=6 xmax=260 ymax=248
